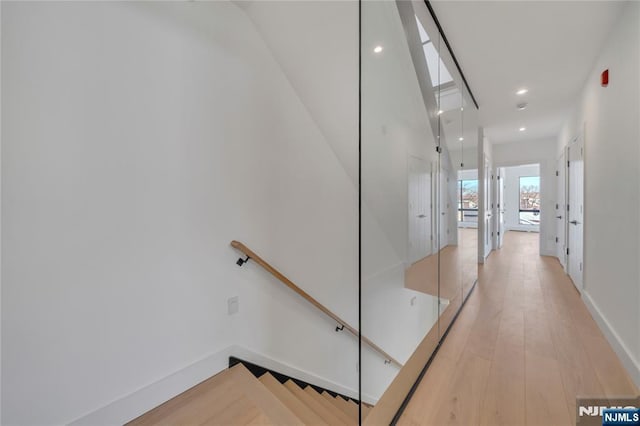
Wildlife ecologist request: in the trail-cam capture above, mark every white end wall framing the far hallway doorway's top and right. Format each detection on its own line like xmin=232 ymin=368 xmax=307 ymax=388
xmin=493 ymin=139 xmax=557 ymax=256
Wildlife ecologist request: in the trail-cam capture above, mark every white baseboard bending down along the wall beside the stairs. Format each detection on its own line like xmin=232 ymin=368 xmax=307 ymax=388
xmin=69 ymin=345 xmax=377 ymax=426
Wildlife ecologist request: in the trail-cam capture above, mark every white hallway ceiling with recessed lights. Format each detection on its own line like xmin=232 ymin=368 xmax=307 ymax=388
xmin=432 ymin=1 xmax=624 ymax=143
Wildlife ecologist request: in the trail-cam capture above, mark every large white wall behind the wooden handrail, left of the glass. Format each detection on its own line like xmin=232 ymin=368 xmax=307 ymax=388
xmin=2 ymin=2 xmax=372 ymax=424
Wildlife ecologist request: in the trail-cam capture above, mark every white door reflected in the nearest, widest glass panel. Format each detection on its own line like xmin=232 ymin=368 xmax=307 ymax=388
xmin=409 ymin=157 xmax=432 ymax=263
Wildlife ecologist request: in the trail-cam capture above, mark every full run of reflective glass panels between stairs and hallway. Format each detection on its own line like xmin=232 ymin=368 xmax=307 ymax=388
xmin=360 ymin=1 xmax=478 ymax=424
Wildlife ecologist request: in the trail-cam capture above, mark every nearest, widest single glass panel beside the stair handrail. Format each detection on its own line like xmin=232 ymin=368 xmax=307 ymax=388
xmin=361 ymin=1 xmax=439 ymax=412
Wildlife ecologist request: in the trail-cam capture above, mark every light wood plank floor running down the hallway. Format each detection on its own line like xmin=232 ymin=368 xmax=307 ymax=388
xmin=399 ymin=232 xmax=638 ymax=426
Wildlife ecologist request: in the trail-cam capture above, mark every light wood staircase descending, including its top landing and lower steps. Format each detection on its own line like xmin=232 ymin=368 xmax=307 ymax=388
xmin=128 ymin=363 xmax=372 ymax=426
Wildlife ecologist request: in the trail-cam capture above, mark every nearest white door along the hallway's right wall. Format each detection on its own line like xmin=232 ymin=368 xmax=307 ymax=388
xmin=567 ymin=137 xmax=584 ymax=292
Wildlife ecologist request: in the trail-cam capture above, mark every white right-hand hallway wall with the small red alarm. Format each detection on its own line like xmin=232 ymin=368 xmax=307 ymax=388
xmin=557 ymin=2 xmax=640 ymax=386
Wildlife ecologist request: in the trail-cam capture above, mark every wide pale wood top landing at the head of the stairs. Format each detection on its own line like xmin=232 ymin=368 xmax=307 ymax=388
xmin=128 ymin=364 xmax=304 ymax=426
